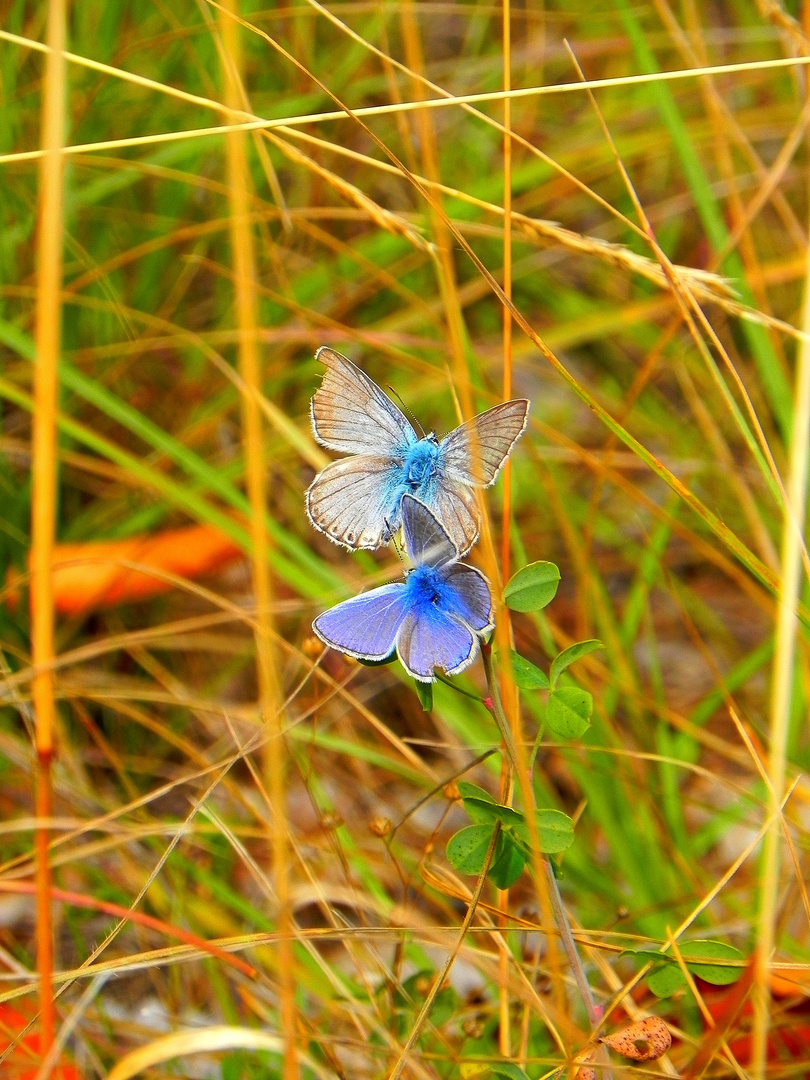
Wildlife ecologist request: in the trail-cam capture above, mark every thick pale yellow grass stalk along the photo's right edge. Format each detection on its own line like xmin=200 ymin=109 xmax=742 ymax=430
xmin=751 ymin=225 xmax=810 ymax=1080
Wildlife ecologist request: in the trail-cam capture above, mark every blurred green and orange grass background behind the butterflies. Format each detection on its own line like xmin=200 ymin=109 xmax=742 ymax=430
xmin=0 ymin=0 xmax=810 ymax=1080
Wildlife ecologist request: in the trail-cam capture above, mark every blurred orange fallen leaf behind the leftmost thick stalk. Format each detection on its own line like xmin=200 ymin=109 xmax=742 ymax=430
xmin=6 ymin=525 xmax=244 ymax=616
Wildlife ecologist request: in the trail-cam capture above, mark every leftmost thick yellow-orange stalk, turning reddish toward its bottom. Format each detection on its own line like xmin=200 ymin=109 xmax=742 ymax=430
xmin=31 ymin=0 xmax=67 ymax=1054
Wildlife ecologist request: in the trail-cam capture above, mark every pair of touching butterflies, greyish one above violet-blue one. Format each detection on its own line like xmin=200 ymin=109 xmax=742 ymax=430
xmin=307 ymin=346 xmax=529 ymax=681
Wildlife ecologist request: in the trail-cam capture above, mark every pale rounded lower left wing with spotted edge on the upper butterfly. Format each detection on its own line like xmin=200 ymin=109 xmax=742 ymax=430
xmin=307 ymin=454 xmax=401 ymax=548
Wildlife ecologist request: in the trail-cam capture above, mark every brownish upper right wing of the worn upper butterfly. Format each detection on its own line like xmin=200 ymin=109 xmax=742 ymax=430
xmin=440 ymin=397 xmax=530 ymax=487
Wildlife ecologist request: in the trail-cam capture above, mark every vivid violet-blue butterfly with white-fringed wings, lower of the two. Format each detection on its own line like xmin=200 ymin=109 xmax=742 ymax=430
xmin=312 ymin=495 xmax=492 ymax=683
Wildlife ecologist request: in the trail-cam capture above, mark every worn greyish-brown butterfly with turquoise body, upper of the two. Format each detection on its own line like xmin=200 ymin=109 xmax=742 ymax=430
xmin=307 ymin=346 xmax=529 ymax=554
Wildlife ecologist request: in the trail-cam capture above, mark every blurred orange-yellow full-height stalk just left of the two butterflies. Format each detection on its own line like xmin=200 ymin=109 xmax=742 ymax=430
xmin=219 ymin=0 xmax=298 ymax=1080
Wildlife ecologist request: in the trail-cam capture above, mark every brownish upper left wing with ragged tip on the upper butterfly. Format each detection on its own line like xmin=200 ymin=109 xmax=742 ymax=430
xmin=312 ymin=346 xmax=417 ymax=457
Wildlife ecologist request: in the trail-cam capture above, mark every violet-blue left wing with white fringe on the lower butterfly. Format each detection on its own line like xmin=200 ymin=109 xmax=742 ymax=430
xmin=312 ymin=582 xmax=407 ymax=660
